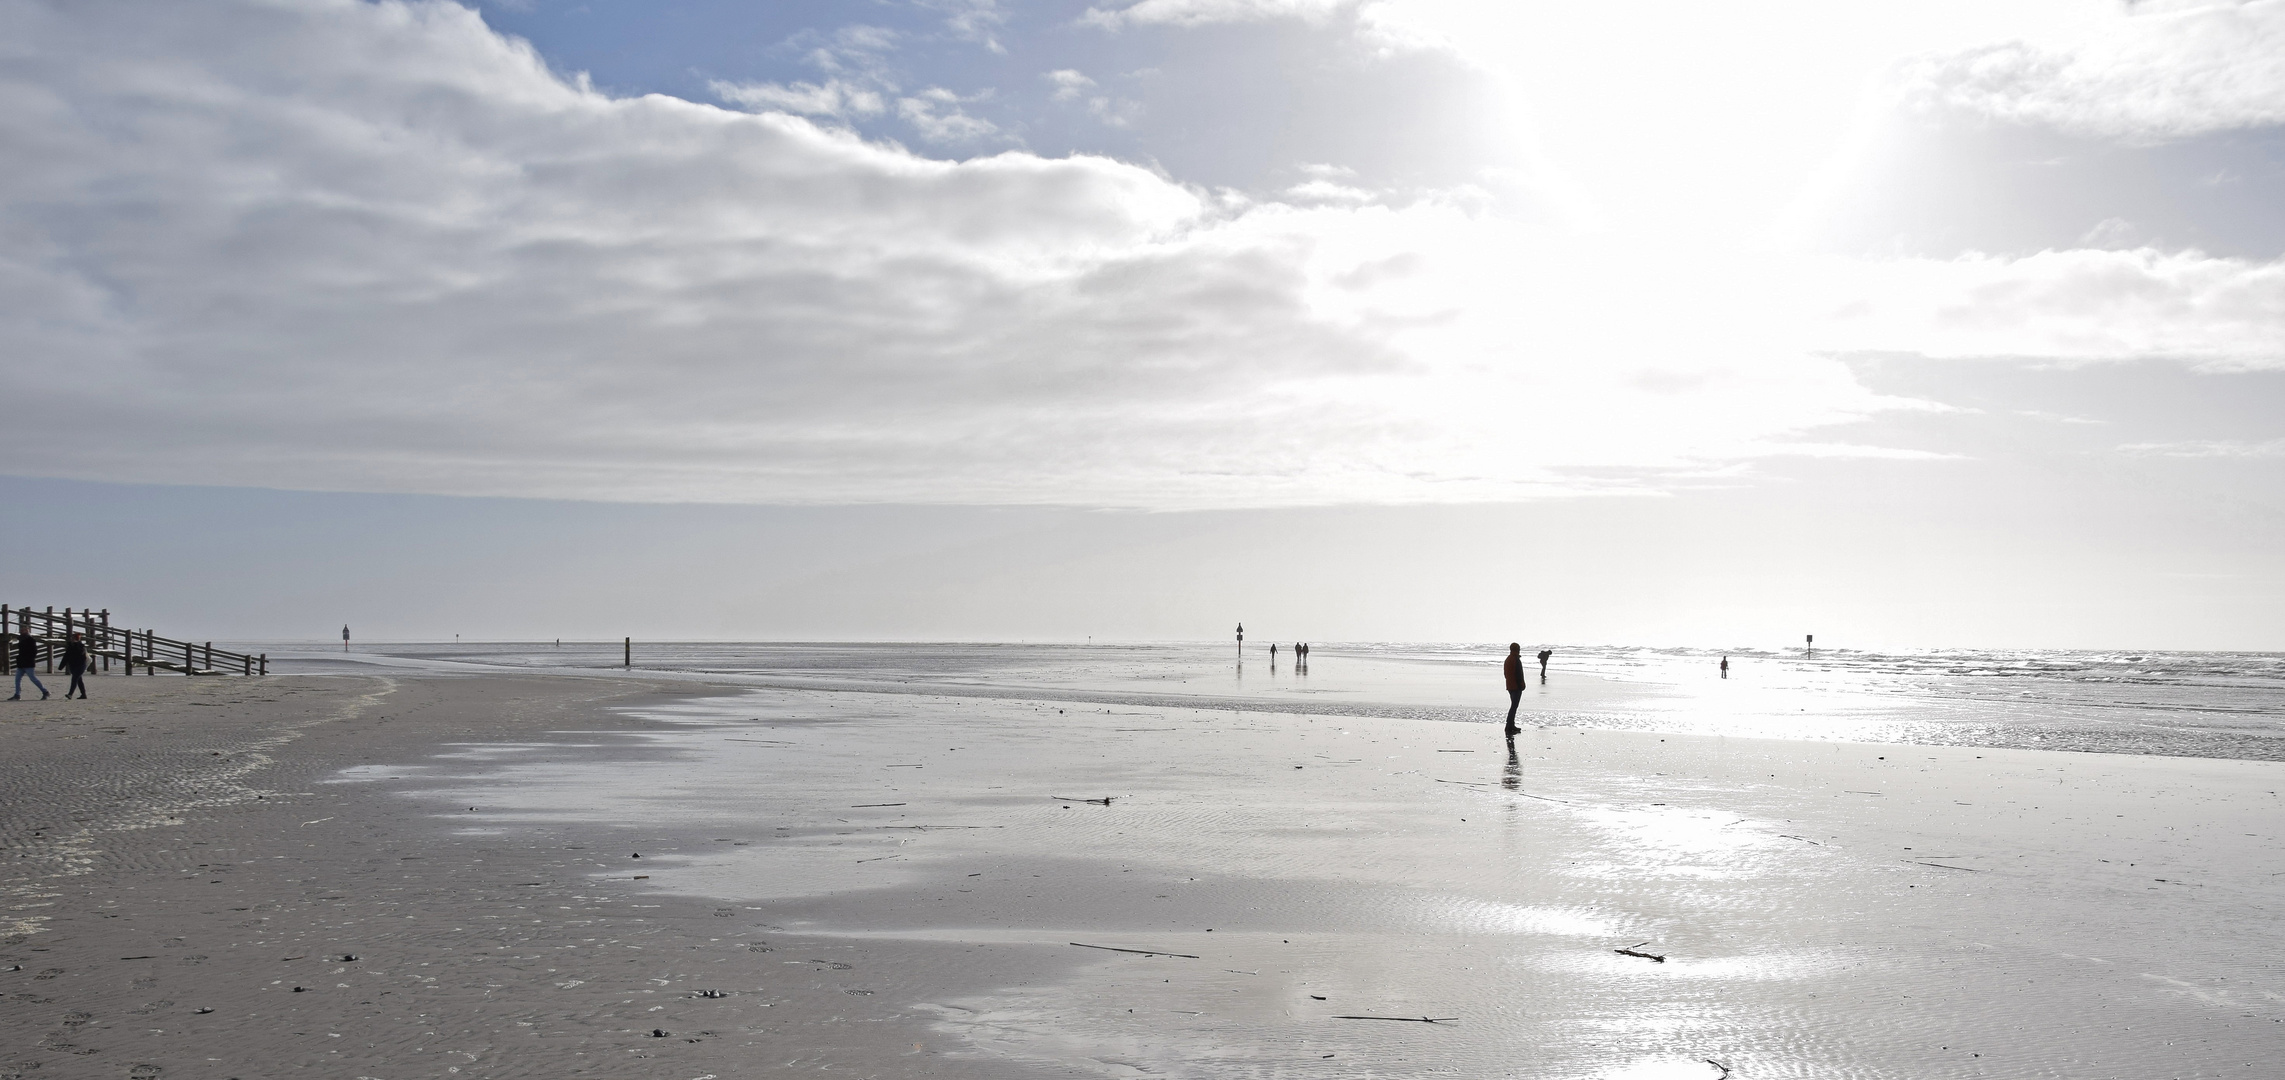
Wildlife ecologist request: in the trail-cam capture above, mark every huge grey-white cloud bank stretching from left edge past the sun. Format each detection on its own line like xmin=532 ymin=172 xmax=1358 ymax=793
xmin=0 ymin=0 xmax=2280 ymax=507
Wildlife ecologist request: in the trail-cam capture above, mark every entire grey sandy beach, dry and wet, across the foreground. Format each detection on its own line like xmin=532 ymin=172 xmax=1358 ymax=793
xmin=0 ymin=669 xmax=2285 ymax=1080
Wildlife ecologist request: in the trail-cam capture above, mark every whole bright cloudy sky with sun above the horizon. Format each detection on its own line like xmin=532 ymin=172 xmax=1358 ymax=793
xmin=0 ymin=0 xmax=2285 ymax=651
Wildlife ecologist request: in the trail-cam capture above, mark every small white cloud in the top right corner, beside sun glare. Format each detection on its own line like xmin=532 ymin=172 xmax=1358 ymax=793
xmin=1901 ymin=0 xmax=2285 ymax=142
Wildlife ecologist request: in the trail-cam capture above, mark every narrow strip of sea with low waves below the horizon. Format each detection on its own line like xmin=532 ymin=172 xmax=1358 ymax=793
xmin=263 ymin=642 xmax=2285 ymax=760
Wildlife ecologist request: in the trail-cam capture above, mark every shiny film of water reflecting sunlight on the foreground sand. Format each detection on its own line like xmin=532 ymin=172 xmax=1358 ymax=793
xmin=374 ymin=690 xmax=2285 ymax=1080
